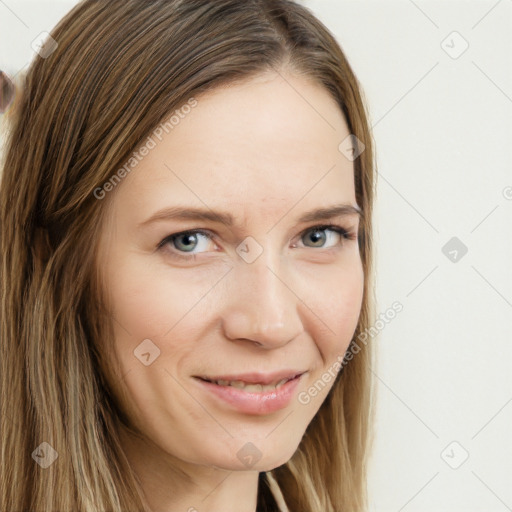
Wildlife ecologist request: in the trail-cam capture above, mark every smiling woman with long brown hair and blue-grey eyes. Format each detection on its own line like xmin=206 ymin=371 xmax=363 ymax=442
xmin=0 ymin=0 xmax=374 ymax=512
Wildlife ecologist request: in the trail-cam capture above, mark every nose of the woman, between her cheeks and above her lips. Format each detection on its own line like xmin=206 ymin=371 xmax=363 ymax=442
xmin=223 ymin=252 xmax=304 ymax=349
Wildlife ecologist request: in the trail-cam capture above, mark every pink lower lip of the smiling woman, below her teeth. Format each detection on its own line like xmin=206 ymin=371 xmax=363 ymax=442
xmin=195 ymin=374 xmax=304 ymax=414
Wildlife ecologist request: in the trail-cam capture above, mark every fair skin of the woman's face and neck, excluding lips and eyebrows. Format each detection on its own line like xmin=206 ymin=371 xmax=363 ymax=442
xmin=100 ymin=69 xmax=364 ymax=512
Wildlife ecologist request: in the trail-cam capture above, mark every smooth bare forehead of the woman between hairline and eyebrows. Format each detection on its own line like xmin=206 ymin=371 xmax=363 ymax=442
xmin=109 ymin=74 xmax=355 ymax=222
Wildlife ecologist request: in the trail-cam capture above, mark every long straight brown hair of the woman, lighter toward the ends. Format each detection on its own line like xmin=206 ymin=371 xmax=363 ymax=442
xmin=0 ymin=0 xmax=375 ymax=512
